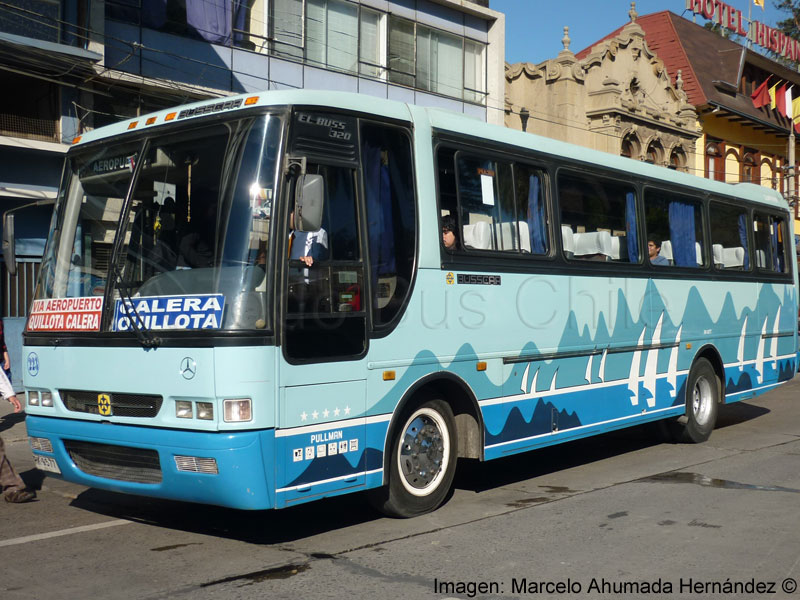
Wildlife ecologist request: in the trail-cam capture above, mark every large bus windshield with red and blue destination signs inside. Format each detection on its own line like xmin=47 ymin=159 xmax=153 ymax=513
xmin=34 ymin=115 xmax=283 ymax=331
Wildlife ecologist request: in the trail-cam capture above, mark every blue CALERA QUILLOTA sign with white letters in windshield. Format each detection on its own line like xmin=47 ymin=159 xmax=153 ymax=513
xmin=112 ymin=294 xmax=225 ymax=331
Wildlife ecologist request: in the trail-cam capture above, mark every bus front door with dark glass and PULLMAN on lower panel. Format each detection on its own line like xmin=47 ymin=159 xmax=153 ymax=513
xmin=276 ymin=165 xmax=367 ymax=507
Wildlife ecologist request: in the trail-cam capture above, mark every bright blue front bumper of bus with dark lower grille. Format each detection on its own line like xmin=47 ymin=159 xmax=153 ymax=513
xmin=26 ymin=415 xmax=275 ymax=510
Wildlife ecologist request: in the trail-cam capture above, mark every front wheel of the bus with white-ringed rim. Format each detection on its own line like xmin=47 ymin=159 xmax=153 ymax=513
xmin=370 ymin=399 xmax=458 ymax=518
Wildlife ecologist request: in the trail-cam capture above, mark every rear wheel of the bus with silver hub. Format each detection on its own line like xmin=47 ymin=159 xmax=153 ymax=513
xmin=675 ymin=358 xmax=722 ymax=444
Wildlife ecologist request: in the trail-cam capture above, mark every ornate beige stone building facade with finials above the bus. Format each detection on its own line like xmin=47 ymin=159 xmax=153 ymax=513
xmin=506 ymin=9 xmax=700 ymax=171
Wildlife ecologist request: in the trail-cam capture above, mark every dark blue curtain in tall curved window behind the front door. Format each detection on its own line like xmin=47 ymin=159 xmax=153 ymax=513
xmin=362 ymin=141 xmax=397 ymax=302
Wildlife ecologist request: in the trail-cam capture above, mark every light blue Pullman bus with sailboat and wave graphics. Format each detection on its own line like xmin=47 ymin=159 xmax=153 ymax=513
xmin=14 ymin=90 xmax=798 ymax=517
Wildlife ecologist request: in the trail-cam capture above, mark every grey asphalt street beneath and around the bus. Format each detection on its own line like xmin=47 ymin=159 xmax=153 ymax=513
xmin=0 ymin=378 xmax=800 ymax=600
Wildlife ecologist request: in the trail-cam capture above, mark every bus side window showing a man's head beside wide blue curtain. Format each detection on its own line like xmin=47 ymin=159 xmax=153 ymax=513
xmin=644 ymin=189 xmax=708 ymax=269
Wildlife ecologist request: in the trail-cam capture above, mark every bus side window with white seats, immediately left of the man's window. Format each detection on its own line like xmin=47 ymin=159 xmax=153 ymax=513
xmin=558 ymin=173 xmax=639 ymax=263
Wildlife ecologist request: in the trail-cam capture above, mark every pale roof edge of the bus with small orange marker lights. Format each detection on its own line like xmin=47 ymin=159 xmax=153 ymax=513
xmin=73 ymin=90 xmax=787 ymax=210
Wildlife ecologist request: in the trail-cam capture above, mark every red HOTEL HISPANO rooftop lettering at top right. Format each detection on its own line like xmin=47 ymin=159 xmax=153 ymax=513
xmin=686 ymin=0 xmax=800 ymax=61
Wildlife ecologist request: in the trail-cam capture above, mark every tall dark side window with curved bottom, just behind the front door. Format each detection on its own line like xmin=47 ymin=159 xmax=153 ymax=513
xmin=361 ymin=124 xmax=416 ymax=329
